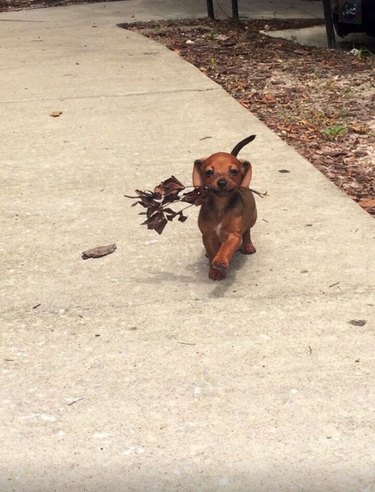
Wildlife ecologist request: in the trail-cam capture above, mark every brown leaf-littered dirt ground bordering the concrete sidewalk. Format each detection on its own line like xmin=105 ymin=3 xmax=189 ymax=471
xmin=0 ymin=0 xmax=375 ymax=216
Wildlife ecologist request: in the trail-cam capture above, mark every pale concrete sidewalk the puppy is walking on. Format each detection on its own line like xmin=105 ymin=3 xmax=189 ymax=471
xmin=0 ymin=1 xmax=375 ymax=492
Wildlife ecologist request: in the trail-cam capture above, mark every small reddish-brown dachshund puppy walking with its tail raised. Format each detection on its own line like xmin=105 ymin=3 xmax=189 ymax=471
xmin=193 ymin=135 xmax=257 ymax=280
